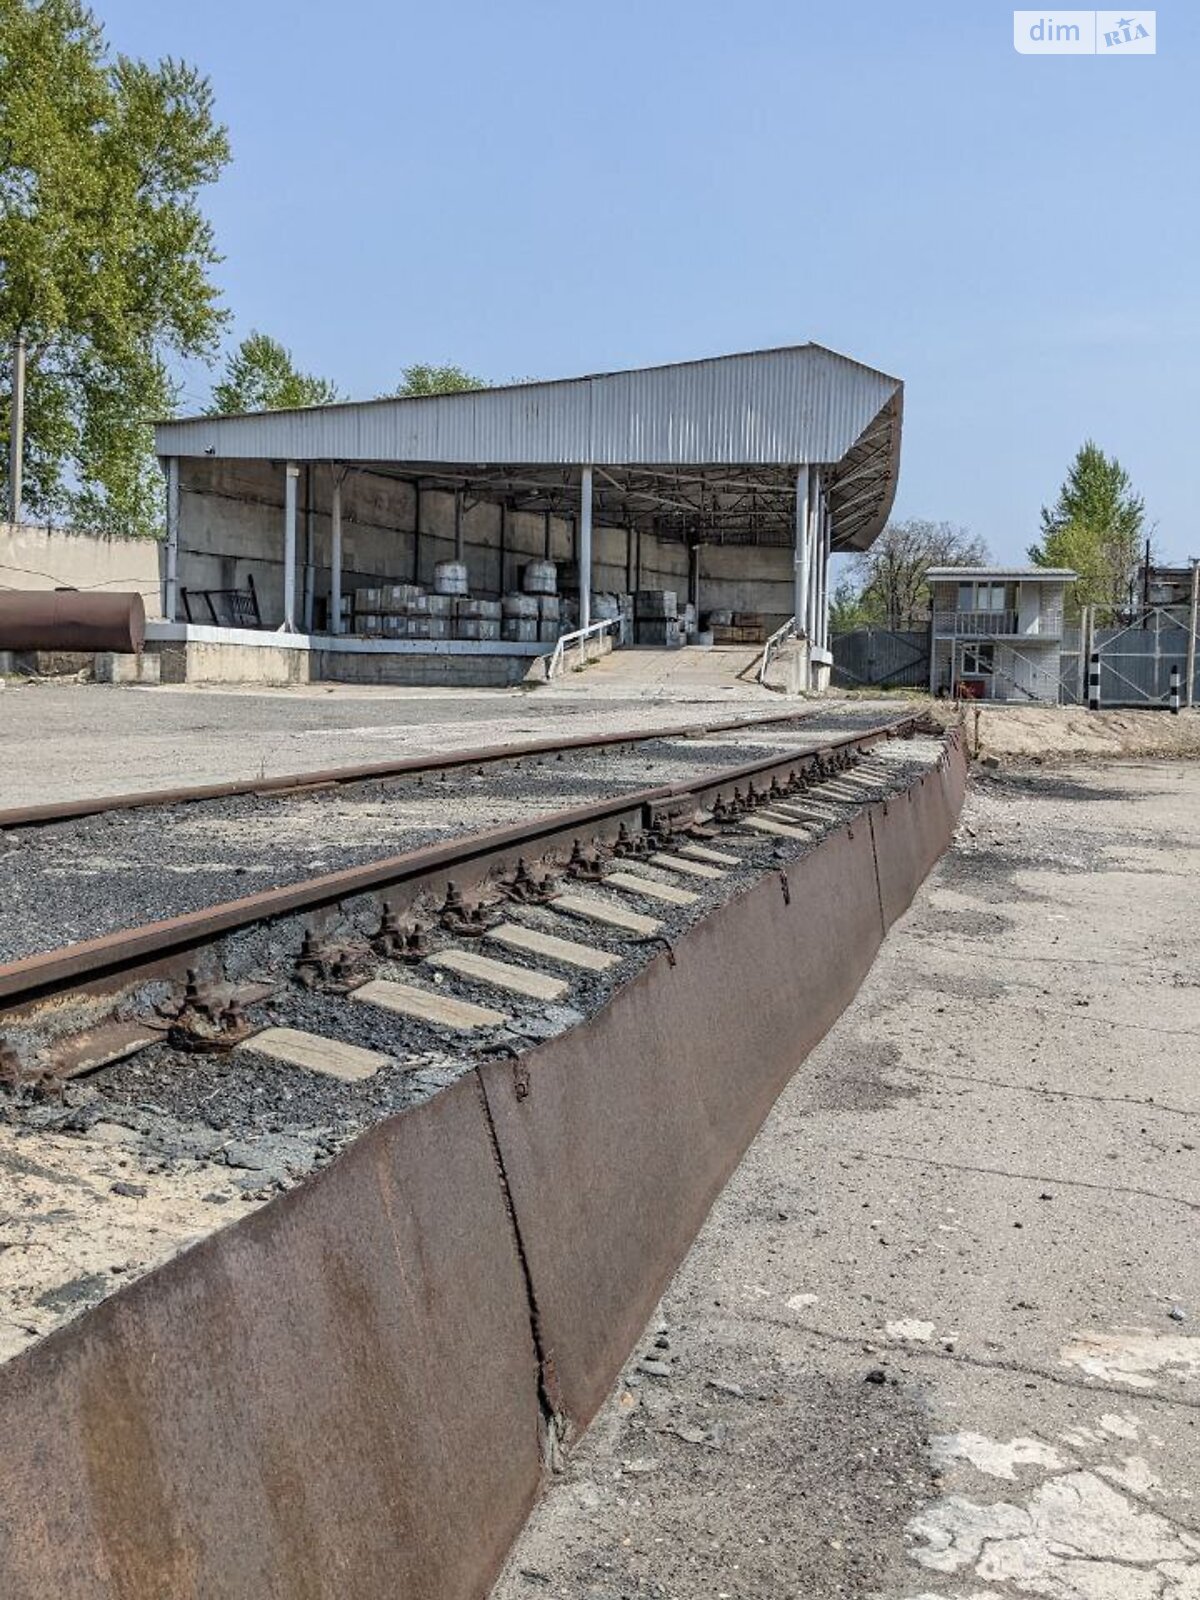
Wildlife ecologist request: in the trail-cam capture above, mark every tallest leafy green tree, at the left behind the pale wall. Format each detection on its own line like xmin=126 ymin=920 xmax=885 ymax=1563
xmin=0 ymin=0 xmax=229 ymax=534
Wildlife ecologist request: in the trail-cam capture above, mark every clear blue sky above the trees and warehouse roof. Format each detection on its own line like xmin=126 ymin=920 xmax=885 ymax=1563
xmin=96 ymin=0 xmax=1200 ymax=558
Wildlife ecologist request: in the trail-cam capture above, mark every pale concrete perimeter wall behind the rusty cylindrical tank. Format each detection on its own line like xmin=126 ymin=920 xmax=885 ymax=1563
xmin=0 ymin=522 xmax=163 ymax=618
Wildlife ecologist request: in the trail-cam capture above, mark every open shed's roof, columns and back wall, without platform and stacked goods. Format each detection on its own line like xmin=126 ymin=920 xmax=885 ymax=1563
xmin=157 ymin=344 xmax=902 ymax=684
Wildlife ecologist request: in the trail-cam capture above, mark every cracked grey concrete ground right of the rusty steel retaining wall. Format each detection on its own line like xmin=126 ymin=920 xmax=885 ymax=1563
xmin=494 ymin=762 xmax=1200 ymax=1600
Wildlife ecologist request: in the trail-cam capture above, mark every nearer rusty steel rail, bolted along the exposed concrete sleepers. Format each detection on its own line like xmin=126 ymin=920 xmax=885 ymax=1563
xmin=0 ymin=714 xmax=925 ymax=1011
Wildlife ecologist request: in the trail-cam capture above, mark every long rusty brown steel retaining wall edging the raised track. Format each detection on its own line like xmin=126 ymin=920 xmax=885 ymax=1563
xmin=0 ymin=733 xmax=965 ymax=1600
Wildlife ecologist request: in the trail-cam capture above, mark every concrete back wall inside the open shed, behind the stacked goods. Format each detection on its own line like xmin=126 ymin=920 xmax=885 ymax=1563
xmin=179 ymin=461 xmax=792 ymax=627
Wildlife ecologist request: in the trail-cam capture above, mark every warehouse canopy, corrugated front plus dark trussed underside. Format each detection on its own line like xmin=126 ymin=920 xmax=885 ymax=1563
xmin=155 ymin=344 xmax=904 ymax=550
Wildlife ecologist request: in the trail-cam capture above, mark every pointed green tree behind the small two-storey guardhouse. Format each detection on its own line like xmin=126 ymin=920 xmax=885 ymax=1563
xmin=1029 ymin=438 xmax=1146 ymax=610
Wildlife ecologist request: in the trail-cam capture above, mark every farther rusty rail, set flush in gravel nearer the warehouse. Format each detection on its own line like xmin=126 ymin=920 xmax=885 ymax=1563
xmin=0 ymin=707 xmax=908 ymax=832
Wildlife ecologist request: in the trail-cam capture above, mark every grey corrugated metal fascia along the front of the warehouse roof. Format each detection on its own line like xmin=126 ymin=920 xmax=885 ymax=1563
xmin=155 ymin=344 xmax=902 ymax=466
